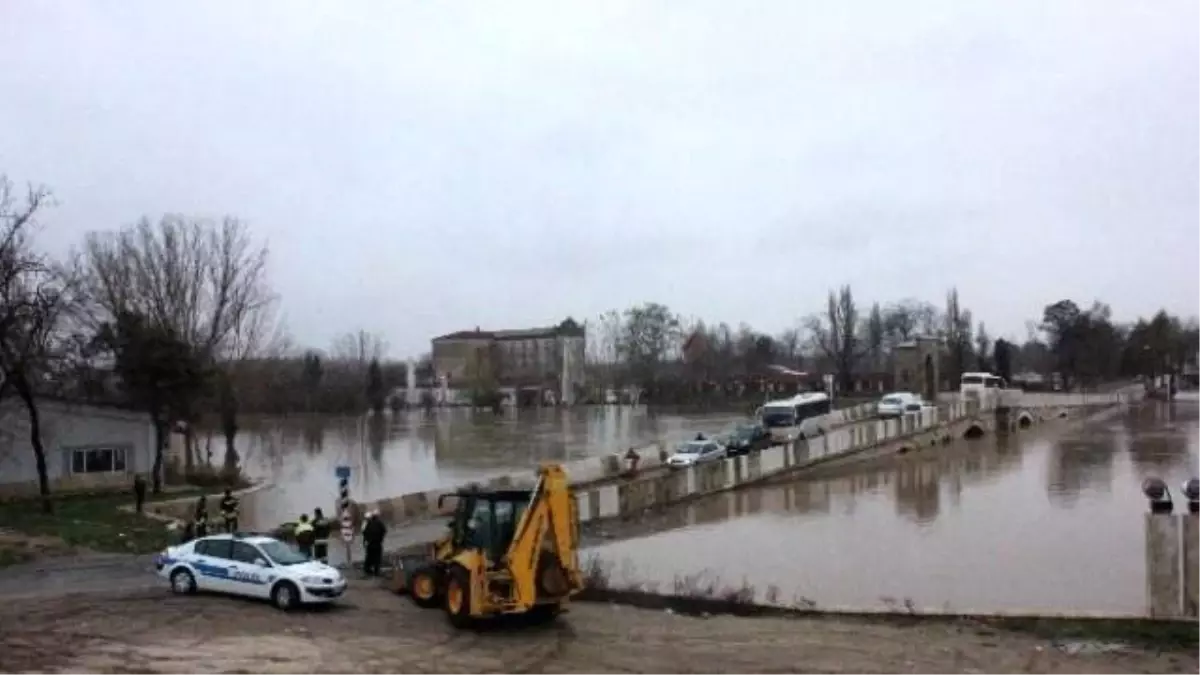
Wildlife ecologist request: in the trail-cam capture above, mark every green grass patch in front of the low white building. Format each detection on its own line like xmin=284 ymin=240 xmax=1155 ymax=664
xmin=0 ymin=492 xmax=180 ymax=565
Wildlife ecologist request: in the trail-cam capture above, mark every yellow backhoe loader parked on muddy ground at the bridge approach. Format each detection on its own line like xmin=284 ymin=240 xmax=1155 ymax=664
xmin=396 ymin=465 xmax=583 ymax=628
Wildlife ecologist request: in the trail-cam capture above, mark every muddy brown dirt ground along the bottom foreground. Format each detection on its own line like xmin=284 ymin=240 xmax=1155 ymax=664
xmin=0 ymin=585 xmax=1200 ymax=675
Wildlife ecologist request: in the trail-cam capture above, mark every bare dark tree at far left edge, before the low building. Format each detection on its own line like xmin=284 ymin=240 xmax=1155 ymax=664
xmin=0 ymin=177 xmax=79 ymax=513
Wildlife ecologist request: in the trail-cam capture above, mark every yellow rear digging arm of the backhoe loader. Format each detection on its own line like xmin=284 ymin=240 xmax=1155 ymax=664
xmin=504 ymin=465 xmax=583 ymax=610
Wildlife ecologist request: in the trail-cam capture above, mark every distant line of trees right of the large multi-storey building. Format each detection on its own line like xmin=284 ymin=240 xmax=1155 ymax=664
xmin=587 ymin=286 xmax=1200 ymax=402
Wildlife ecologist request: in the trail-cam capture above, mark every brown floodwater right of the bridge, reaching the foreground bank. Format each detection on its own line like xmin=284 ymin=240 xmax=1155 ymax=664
xmin=592 ymin=402 xmax=1200 ymax=615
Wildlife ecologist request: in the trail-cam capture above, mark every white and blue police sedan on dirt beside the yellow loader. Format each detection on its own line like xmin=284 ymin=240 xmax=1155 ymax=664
xmin=155 ymin=533 xmax=346 ymax=610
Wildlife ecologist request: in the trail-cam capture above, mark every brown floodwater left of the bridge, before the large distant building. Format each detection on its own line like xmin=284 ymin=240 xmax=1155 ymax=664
xmin=200 ymin=406 xmax=740 ymax=527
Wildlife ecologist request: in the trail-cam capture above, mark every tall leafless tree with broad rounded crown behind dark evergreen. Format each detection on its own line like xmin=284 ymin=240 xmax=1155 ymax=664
xmin=84 ymin=215 xmax=275 ymax=489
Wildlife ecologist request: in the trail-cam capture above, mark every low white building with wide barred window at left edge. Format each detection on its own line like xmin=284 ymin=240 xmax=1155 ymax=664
xmin=0 ymin=396 xmax=155 ymax=497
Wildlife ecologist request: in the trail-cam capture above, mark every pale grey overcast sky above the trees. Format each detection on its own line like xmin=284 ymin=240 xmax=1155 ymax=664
xmin=0 ymin=0 xmax=1200 ymax=356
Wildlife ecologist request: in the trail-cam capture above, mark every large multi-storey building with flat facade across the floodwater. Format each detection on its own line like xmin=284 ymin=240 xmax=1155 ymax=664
xmin=432 ymin=318 xmax=587 ymax=398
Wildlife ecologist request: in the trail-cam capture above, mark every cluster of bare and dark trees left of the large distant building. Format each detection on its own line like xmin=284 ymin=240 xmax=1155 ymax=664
xmin=0 ymin=177 xmax=417 ymax=510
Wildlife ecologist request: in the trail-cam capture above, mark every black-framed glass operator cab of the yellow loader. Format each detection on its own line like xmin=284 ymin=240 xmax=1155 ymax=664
xmin=439 ymin=490 xmax=533 ymax=565
